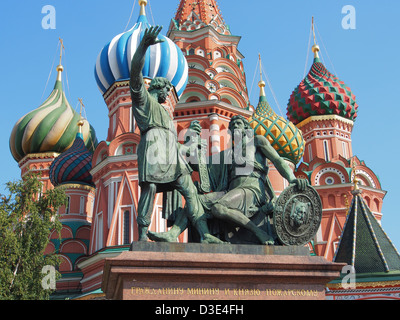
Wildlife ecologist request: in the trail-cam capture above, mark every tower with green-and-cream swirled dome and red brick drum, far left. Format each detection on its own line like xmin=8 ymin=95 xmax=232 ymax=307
xmin=10 ymin=43 xmax=97 ymax=191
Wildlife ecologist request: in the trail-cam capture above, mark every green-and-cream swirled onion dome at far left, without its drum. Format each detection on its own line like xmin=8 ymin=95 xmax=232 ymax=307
xmin=10 ymin=65 xmax=97 ymax=162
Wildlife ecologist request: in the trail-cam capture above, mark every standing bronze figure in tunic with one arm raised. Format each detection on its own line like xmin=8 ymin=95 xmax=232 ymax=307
xmin=130 ymin=26 xmax=221 ymax=243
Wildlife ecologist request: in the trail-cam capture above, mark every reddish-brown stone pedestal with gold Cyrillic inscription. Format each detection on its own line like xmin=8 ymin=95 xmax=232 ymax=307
xmin=102 ymin=242 xmax=344 ymax=300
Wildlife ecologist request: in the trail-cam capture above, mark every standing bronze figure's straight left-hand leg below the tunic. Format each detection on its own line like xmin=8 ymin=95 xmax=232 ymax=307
xmin=137 ymin=183 xmax=157 ymax=241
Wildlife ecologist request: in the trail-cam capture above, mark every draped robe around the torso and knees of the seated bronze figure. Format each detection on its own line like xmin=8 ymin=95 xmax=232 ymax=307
xmin=200 ymin=140 xmax=275 ymax=243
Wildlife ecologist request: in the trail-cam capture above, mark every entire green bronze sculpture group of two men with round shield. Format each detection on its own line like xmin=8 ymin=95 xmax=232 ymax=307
xmin=130 ymin=26 xmax=322 ymax=245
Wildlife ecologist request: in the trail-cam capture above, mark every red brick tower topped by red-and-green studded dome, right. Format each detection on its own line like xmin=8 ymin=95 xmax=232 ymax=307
xmin=287 ymin=24 xmax=386 ymax=260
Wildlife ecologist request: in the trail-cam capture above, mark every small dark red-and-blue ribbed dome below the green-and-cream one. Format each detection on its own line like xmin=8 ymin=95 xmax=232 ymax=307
xmin=49 ymin=121 xmax=94 ymax=187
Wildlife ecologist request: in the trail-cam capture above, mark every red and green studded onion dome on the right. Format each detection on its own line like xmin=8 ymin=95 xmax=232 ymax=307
xmin=287 ymin=45 xmax=358 ymax=125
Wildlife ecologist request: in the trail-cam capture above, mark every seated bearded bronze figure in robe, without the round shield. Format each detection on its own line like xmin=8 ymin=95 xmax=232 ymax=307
xmin=149 ymin=116 xmax=308 ymax=245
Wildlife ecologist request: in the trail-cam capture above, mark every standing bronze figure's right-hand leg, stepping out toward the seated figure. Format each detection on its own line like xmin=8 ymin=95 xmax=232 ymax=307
xmin=175 ymin=175 xmax=223 ymax=243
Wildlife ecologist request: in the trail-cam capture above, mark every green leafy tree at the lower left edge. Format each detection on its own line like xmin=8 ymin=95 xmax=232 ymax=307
xmin=0 ymin=173 xmax=67 ymax=300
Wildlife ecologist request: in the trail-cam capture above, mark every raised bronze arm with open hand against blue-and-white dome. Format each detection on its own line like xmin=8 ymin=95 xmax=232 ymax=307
xmin=130 ymin=26 xmax=164 ymax=91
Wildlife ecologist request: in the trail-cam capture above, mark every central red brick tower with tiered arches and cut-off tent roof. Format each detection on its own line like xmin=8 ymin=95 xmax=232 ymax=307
xmin=168 ymin=0 xmax=252 ymax=154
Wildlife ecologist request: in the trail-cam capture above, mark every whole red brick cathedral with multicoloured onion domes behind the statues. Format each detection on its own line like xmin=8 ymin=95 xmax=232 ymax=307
xmin=6 ymin=0 xmax=400 ymax=299
